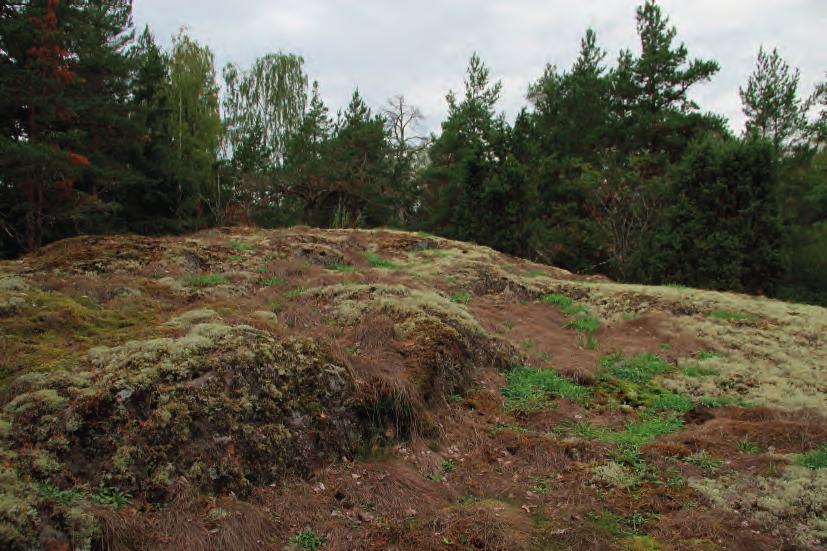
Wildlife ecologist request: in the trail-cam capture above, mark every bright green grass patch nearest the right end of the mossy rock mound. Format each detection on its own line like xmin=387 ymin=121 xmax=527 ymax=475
xmin=502 ymin=366 xmax=591 ymax=413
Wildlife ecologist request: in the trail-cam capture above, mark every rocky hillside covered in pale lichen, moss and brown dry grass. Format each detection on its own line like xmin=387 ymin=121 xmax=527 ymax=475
xmin=0 ymin=228 xmax=827 ymax=551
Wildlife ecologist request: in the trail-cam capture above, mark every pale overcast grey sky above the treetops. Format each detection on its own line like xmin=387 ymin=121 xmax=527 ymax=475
xmin=134 ymin=0 xmax=827 ymax=132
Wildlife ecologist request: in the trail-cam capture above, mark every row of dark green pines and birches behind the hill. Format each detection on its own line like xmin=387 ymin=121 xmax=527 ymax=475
xmin=0 ymin=0 xmax=827 ymax=303
